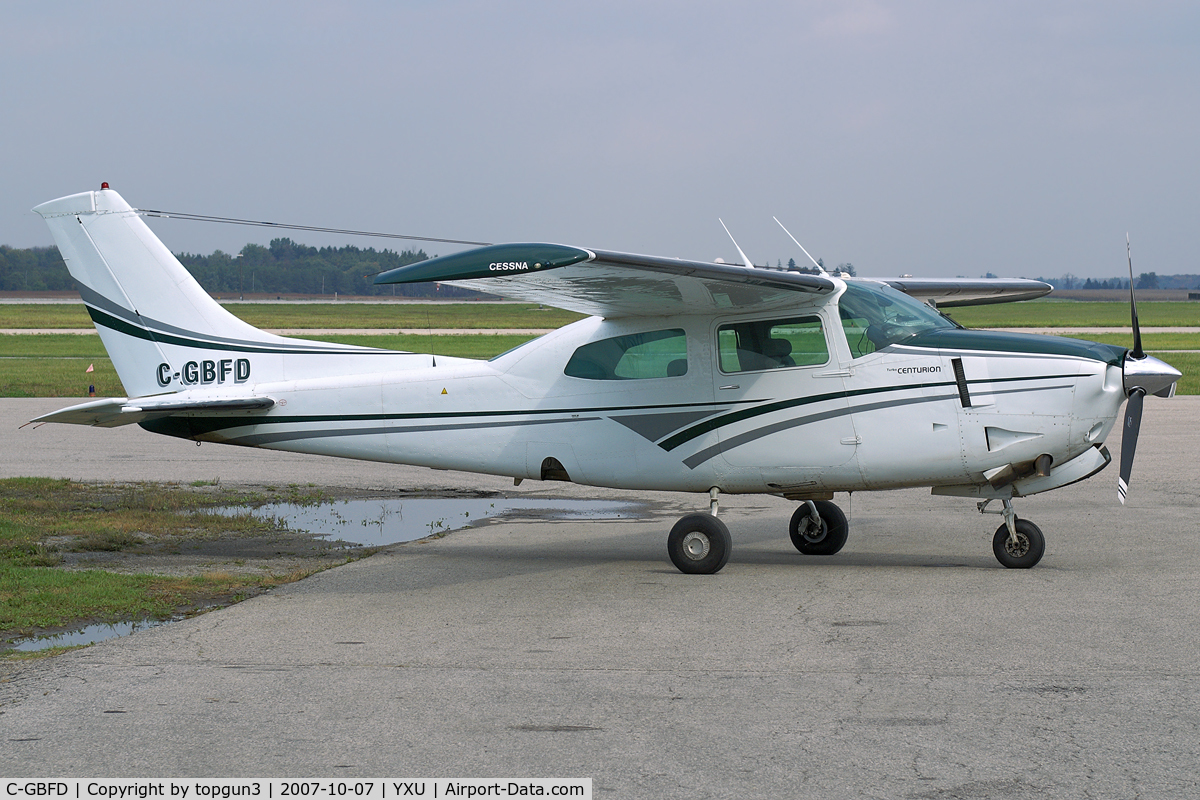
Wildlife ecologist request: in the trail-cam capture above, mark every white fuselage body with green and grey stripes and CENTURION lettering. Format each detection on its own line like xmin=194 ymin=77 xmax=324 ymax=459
xmin=145 ymin=300 xmax=1124 ymax=497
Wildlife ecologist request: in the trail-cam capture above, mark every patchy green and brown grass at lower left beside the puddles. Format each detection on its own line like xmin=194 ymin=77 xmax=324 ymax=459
xmin=0 ymin=479 xmax=345 ymax=642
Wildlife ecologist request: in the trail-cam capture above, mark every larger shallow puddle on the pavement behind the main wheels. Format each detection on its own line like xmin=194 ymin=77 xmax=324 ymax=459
xmin=218 ymin=498 xmax=641 ymax=547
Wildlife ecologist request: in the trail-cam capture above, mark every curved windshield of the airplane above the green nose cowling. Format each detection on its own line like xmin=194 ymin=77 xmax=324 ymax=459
xmin=838 ymin=281 xmax=956 ymax=359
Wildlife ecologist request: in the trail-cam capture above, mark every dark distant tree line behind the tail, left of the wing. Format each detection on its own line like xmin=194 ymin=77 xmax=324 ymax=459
xmin=0 ymin=239 xmax=479 ymax=297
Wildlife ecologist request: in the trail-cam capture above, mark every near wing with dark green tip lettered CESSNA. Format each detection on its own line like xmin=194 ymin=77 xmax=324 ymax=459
xmin=374 ymin=243 xmax=835 ymax=318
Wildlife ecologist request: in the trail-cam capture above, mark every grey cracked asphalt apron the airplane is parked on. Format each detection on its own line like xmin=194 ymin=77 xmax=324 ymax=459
xmin=0 ymin=397 xmax=1200 ymax=798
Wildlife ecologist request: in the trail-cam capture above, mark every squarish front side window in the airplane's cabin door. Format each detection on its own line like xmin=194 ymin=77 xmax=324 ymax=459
xmin=716 ymin=317 xmax=829 ymax=372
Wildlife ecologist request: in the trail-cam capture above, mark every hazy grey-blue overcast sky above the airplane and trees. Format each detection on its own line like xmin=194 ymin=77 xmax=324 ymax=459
xmin=0 ymin=0 xmax=1200 ymax=277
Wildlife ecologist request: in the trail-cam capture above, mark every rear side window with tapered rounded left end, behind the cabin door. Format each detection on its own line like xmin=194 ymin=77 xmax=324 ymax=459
xmin=563 ymin=327 xmax=688 ymax=380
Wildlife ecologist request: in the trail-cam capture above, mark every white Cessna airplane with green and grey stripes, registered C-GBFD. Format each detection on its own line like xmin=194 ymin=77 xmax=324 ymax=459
xmin=34 ymin=184 xmax=1180 ymax=573
